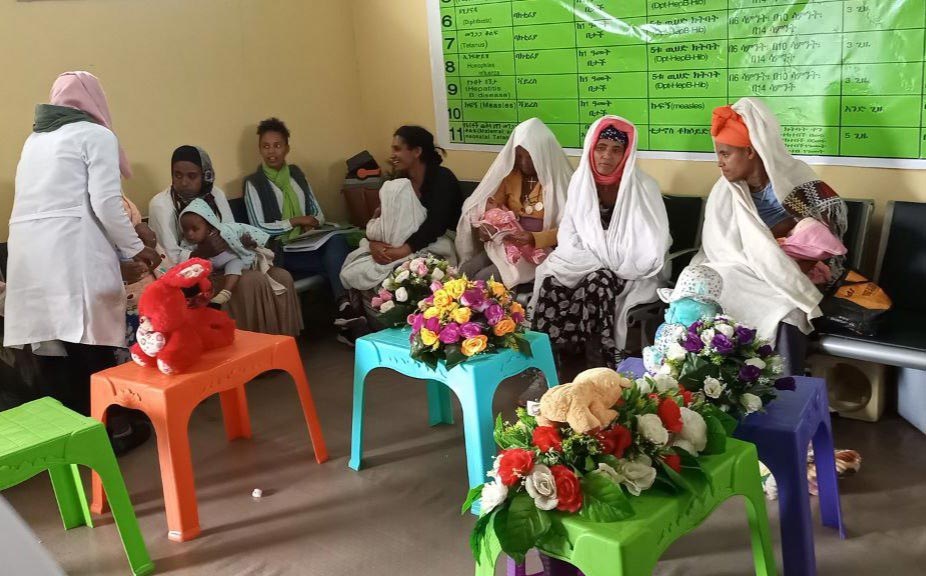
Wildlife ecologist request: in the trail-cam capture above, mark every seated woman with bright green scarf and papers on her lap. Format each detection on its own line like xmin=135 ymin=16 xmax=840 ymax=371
xmin=244 ymin=118 xmax=362 ymax=334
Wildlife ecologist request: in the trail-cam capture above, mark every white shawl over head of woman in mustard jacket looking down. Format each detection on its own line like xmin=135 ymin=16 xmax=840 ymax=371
xmin=456 ymin=118 xmax=573 ymax=288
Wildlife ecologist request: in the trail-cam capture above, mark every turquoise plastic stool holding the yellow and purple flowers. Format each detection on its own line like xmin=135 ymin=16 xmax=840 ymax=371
xmin=348 ymin=328 xmax=559 ymax=504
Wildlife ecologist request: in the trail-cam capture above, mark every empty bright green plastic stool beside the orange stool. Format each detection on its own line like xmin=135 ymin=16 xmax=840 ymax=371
xmin=0 ymin=398 xmax=154 ymax=576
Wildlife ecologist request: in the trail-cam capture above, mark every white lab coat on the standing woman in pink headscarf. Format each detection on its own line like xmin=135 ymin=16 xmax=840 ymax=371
xmin=3 ymin=122 xmax=144 ymax=346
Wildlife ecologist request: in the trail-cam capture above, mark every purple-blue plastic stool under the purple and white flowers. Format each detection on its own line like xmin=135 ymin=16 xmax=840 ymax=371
xmin=618 ymin=358 xmax=846 ymax=576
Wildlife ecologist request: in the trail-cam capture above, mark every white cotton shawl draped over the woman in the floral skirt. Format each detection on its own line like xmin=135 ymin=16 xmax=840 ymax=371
xmin=531 ymin=116 xmax=672 ymax=349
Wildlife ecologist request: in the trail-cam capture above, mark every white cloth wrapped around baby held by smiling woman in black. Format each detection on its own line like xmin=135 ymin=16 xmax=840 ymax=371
xmin=341 ymin=178 xmax=456 ymax=290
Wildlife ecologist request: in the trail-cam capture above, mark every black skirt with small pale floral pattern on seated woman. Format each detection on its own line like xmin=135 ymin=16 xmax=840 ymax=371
xmin=533 ymin=270 xmax=625 ymax=368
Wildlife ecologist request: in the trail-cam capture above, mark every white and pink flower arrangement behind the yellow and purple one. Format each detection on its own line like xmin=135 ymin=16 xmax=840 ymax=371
xmin=370 ymin=254 xmax=457 ymax=326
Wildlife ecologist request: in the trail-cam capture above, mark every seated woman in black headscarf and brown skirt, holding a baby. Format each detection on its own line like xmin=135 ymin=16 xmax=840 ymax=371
xmin=148 ymin=146 xmax=302 ymax=336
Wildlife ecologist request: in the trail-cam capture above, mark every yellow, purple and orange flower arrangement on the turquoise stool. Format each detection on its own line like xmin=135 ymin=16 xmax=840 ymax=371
xmin=406 ymin=276 xmax=531 ymax=370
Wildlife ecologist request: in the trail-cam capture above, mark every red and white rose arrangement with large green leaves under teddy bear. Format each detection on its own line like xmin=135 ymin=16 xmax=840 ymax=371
xmin=463 ymin=375 xmax=732 ymax=561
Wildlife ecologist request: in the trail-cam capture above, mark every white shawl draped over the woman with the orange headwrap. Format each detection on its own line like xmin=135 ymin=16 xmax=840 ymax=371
xmin=692 ymin=98 xmax=823 ymax=341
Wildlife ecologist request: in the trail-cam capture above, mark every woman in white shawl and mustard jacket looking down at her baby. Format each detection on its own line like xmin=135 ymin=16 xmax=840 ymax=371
xmin=456 ymin=118 xmax=573 ymax=288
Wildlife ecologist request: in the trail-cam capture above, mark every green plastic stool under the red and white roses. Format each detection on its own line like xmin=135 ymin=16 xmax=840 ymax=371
xmin=476 ymin=438 xmax=776 ymax=576
